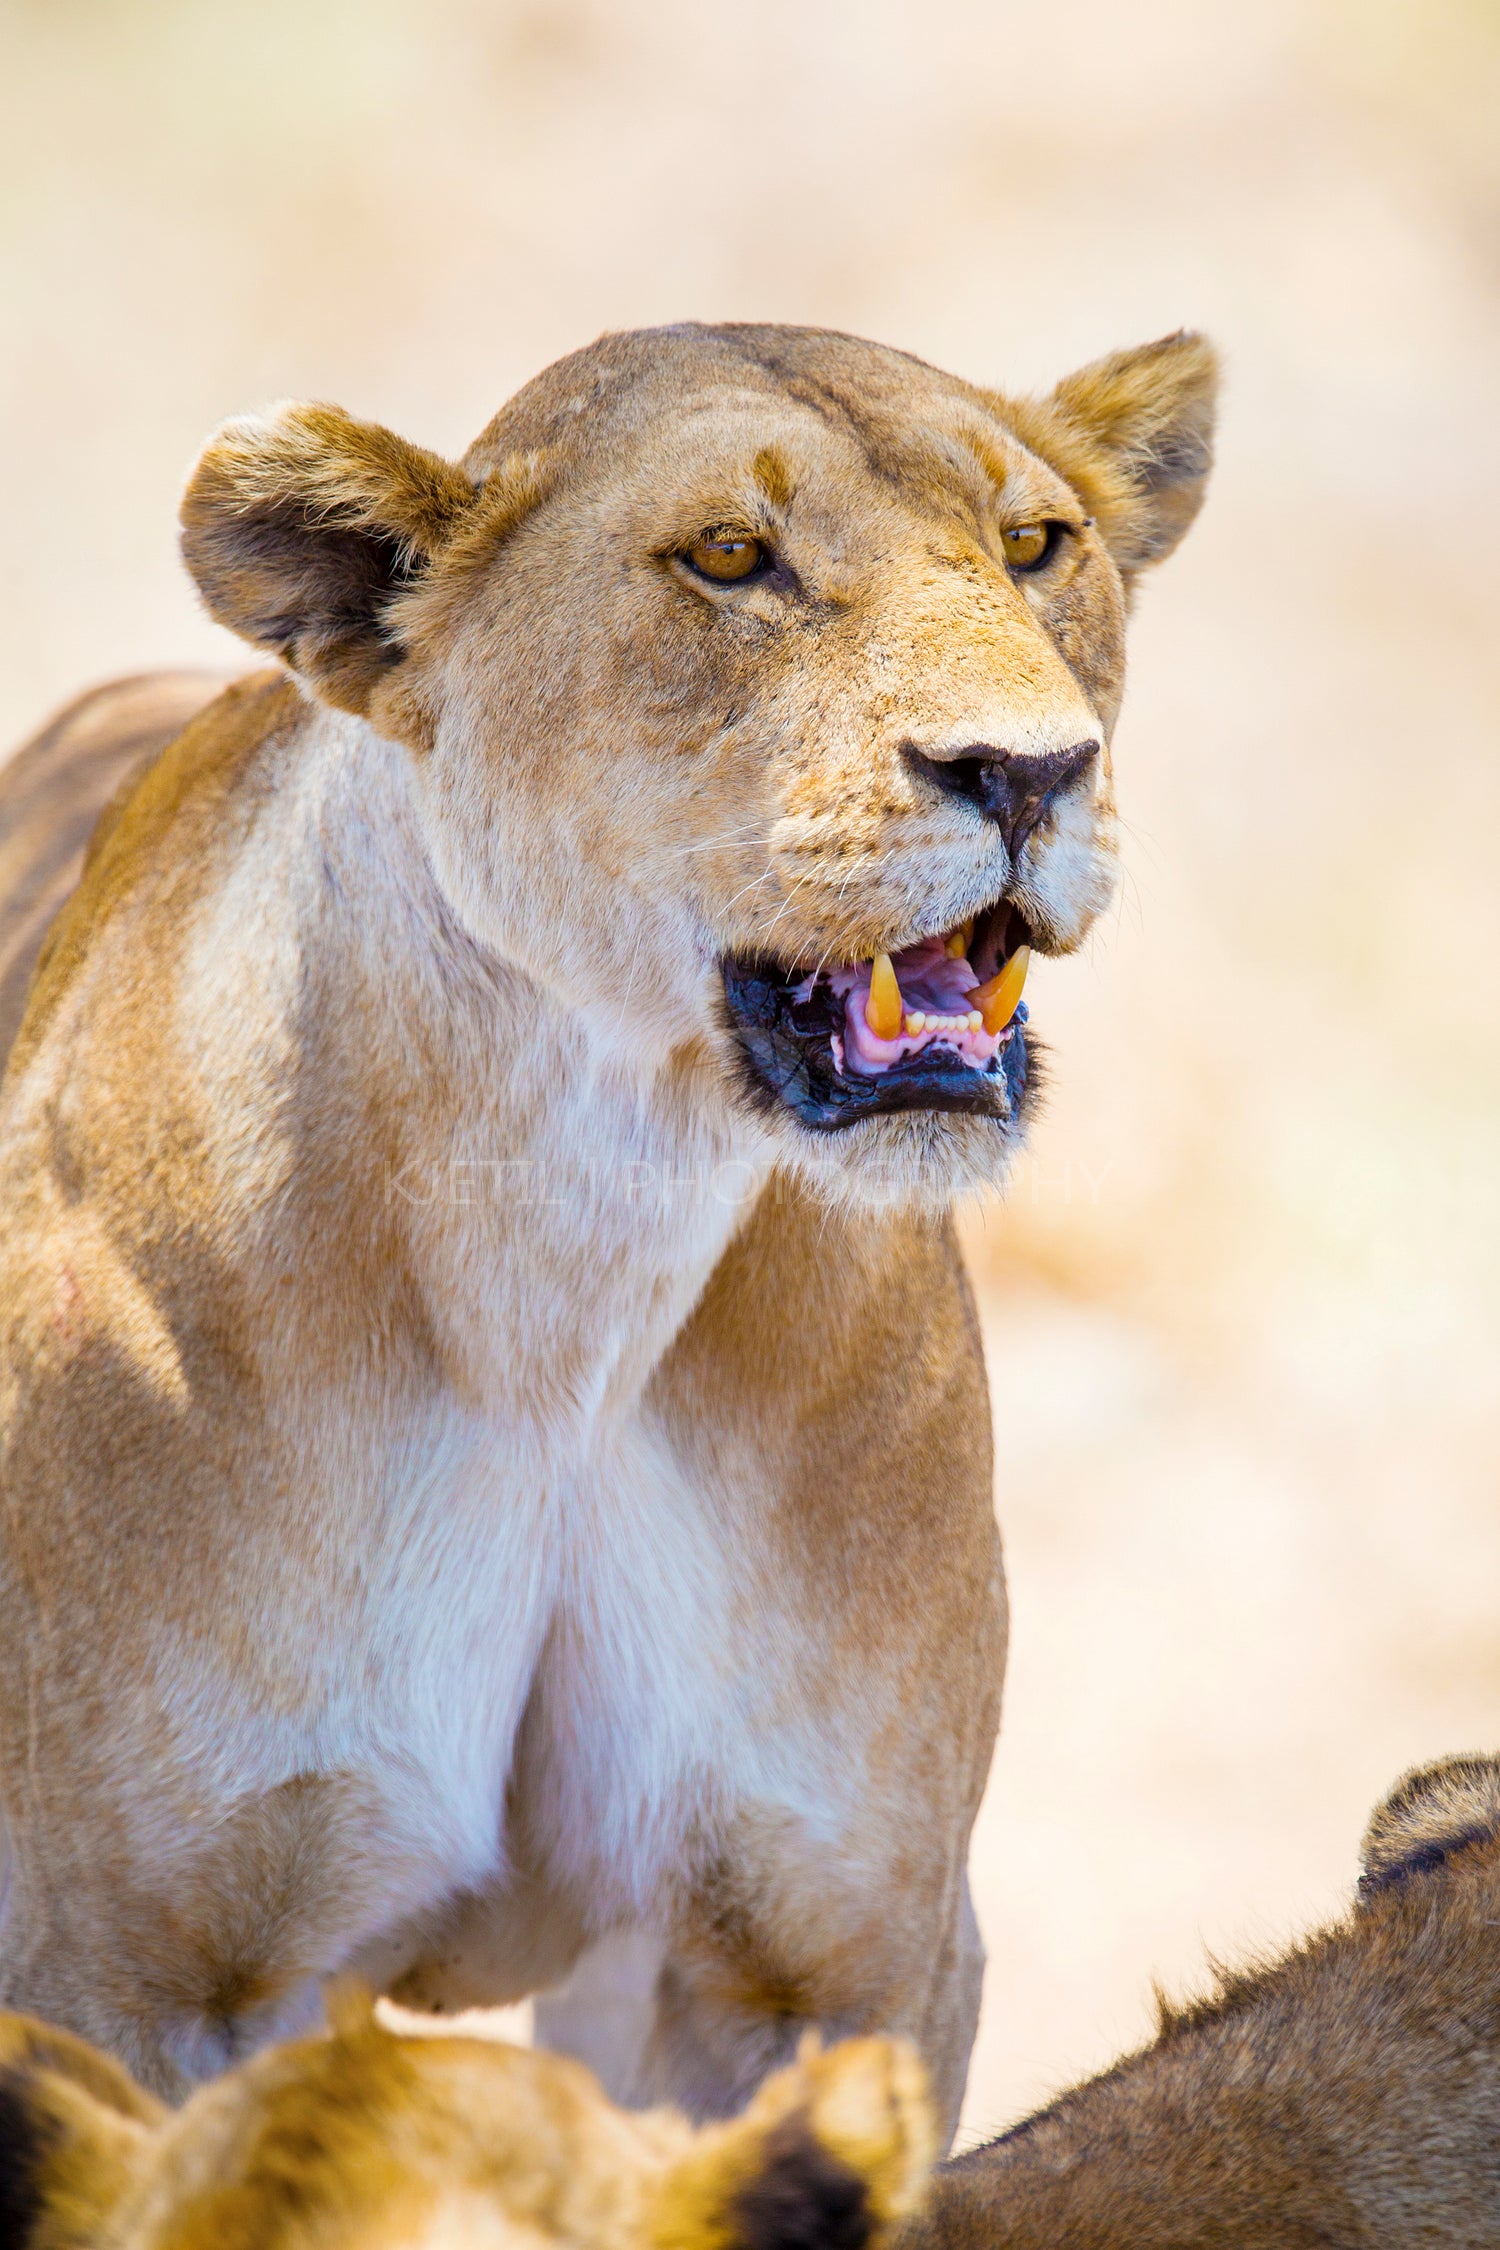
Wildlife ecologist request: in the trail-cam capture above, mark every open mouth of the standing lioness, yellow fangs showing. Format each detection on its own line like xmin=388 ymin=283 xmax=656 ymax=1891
xmin=722 ymin=900 xmax=1032 ymax=1132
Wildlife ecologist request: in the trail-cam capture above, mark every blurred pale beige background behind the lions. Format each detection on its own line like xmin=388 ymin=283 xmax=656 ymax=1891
xmin=0 ymin=0 xmax=1500 ymax=2135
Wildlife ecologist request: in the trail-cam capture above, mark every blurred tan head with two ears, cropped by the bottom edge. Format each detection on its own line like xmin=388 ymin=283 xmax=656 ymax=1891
xmin=0 ymin=1998 xmax=936 ymax=2250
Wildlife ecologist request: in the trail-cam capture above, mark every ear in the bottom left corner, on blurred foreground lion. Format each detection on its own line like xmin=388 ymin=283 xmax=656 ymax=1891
xmin=0 ymin=2014 xmax=166 ymax=2250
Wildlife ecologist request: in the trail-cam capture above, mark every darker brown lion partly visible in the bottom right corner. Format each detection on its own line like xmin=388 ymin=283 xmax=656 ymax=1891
xmin=902 ymin=1757 xmax=1500 ymax=2250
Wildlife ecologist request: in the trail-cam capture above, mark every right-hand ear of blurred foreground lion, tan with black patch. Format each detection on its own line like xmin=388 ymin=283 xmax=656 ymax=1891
xmin=648 ymin=2039 xmax=938 ymax=2250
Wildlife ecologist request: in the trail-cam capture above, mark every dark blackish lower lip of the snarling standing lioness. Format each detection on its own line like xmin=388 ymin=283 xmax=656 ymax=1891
xmin=722 ymin=956 xmax=1032 ymax=1132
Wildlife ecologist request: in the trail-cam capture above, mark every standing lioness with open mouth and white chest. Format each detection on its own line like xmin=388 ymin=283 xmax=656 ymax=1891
xmin=0 ymin=326 xmax=1214 ymax=2126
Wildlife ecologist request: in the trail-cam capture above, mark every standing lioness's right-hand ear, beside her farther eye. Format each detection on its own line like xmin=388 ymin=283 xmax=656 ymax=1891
xmin=1003 ymin=329 xmax=1219 ymax=581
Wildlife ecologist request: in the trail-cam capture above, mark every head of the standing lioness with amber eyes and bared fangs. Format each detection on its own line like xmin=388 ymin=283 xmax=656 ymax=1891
xmin=182 ymin=326 xmax=1214 ymax=1199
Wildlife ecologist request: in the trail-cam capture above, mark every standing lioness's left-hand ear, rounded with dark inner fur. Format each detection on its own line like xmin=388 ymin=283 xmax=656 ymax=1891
xmin=182 ymin=405 xmax=477 ymax=713
